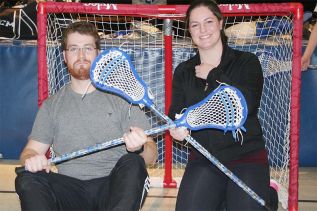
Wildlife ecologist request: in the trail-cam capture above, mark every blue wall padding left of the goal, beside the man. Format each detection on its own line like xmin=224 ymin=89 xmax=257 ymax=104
xmin=0 ymin=44 xmax=37 ymax=159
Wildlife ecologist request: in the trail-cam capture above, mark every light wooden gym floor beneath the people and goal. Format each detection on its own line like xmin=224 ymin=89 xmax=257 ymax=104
xmin=0 ymin=159 xmax=317 ymax=211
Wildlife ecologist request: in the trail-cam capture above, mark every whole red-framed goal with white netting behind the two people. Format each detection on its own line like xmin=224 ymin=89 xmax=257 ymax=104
xmin=37 ymin=2 xmax=302 ymax=210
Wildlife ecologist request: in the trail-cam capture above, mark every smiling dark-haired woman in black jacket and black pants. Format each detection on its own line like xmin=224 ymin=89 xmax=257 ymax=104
xmin=169 ymin=0 xmax=270 ymax=211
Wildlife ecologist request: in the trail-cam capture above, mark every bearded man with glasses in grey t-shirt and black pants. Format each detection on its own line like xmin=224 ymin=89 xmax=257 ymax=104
xmin=16 ymin=22 xmax=157 ymax=211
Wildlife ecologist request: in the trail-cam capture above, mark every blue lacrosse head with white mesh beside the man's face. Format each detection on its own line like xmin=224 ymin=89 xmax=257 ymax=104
xmin=90 ymin=48 xmax=153 ymax=106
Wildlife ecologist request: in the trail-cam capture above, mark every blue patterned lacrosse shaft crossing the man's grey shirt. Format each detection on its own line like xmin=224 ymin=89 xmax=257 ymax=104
xmin=15 ymin=122 xmax=176 ymax=173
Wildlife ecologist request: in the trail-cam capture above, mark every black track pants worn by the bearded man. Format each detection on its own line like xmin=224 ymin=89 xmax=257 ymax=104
xmin=15 ymin=153 xmax=148 ymax=211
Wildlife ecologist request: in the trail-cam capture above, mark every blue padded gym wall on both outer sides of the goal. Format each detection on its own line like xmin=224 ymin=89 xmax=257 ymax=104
xmin=0 ymin=41 xmax=317 ymax=166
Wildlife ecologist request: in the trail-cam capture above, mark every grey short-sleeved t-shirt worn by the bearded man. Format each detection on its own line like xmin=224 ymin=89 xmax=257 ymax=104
xmin=29 ymin=85 xmax=150 ymax=180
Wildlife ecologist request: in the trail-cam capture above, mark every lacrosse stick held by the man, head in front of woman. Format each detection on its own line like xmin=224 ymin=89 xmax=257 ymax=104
xmin=16 ymin=86 xmax=242 ymax=173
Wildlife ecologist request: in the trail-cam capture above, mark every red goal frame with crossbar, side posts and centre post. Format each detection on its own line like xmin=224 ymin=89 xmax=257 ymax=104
xmin=37 ymin=2 xmax=303 ymax=210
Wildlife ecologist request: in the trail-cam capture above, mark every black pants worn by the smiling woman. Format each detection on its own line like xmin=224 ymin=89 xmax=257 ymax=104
xmin=176 ymin=161 xmax=270 ymax=211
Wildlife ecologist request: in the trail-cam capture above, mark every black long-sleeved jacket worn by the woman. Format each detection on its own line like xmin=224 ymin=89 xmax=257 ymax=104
xmin=169 ymin=46 xmax=265 ymax=162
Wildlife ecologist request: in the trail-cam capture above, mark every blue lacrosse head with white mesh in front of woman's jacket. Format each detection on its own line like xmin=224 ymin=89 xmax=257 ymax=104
xmin=175 ymin=85 xmax=248 ymax=132
